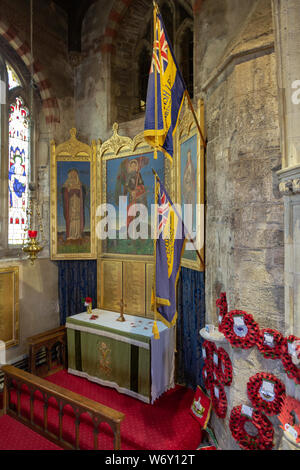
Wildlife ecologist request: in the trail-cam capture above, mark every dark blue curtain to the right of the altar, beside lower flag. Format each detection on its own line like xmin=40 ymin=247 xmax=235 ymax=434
xmin=177 ymin=268 xmax=205 ymax=389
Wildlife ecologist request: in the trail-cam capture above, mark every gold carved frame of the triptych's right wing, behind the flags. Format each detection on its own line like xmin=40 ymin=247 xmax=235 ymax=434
xmin=175 ymin=100 xmax=205 ymax=271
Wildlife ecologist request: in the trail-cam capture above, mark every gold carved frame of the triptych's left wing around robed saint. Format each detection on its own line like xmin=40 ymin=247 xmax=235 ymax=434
xmin=50 ymin=128 xmax=97 ymax=260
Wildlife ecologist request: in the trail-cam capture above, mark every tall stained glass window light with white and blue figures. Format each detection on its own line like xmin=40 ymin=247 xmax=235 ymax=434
xmin=8 ymin=97 xmax=30 ymax=245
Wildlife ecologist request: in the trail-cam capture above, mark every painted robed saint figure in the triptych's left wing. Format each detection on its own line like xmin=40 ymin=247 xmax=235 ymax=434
xmin=62 ymin=168 xmax=85 ymax=240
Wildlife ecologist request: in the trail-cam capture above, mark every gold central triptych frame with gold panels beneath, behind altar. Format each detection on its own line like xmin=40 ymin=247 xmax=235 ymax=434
xmin=96 ymin=123 xmax=175 ymax=318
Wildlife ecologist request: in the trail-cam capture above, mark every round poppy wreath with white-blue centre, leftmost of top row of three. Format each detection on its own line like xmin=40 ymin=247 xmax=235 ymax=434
xmin=222 ymin=310 xmax=259 ymax=349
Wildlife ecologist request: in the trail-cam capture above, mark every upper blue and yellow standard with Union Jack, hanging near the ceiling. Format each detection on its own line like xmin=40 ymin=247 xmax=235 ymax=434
xmin=144 ymin=4 xmax=186 ymax=161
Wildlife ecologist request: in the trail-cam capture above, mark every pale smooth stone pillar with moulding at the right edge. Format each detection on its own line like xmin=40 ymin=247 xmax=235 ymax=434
xmin=272 ymin=0 xmax=300 ymax=336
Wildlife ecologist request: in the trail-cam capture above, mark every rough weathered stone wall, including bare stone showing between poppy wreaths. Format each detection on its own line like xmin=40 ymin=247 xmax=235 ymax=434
xmin=195 ymin=0 xmax=285 ymax=449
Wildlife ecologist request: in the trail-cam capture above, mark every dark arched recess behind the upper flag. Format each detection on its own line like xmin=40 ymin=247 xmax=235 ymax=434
xmin=102 ymin=0 xmax=193 ymax=126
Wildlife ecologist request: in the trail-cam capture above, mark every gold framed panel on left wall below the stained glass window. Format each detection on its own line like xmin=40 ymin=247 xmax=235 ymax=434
xmin=0 ymin=266 xmax=19 ymax=349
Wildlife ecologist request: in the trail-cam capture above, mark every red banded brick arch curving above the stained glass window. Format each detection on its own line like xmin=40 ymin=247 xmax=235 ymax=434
xmin=0 ymin=18 xmax=60 ymax=124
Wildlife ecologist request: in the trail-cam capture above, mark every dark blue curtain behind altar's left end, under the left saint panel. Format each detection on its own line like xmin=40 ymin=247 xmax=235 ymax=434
xmin=57 ymin=260 xmax=97 ymax=325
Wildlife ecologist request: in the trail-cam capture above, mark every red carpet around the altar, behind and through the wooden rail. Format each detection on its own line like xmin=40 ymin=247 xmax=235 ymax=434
xmin=0 ymin=370 xmax=201 ymax=450
